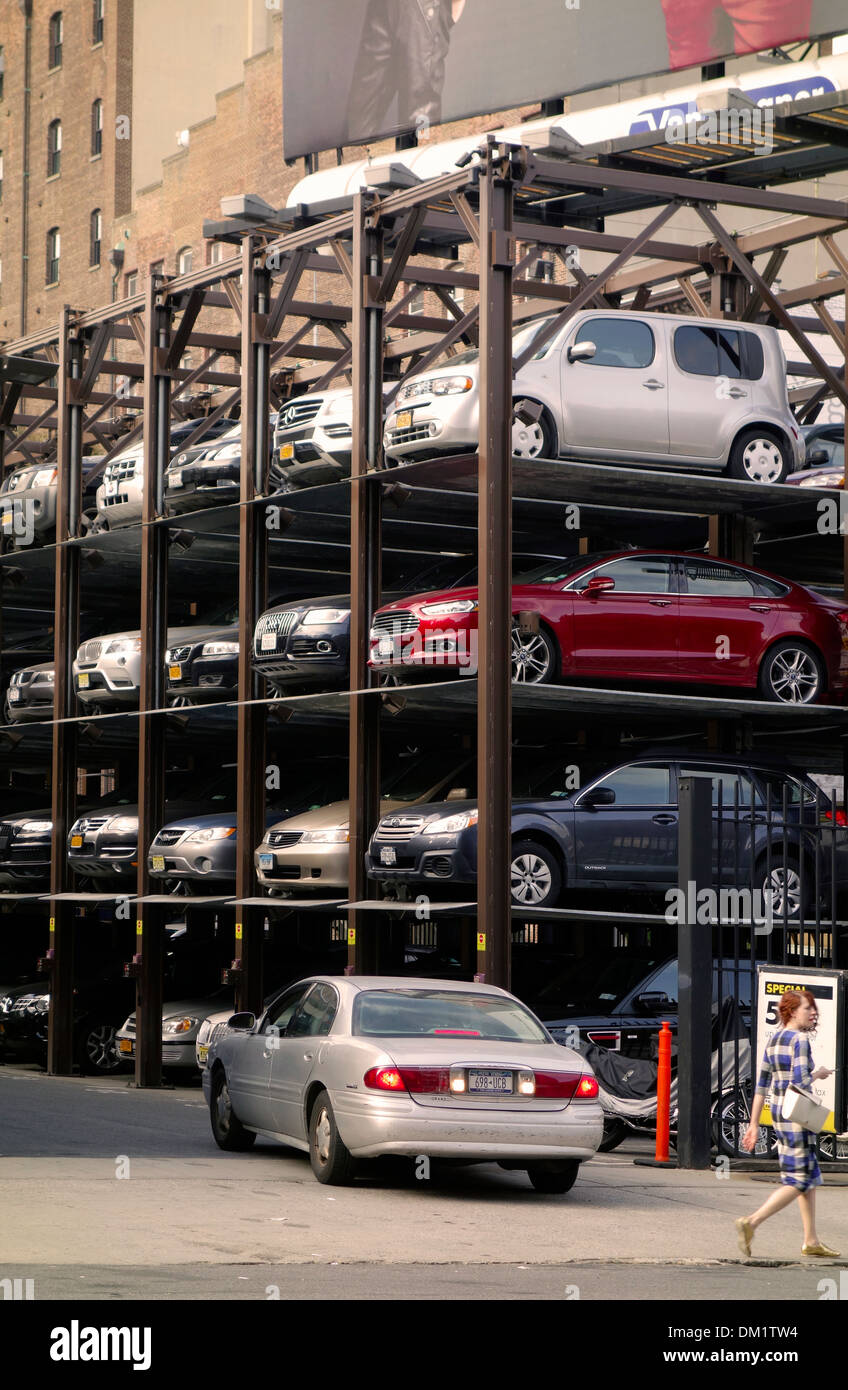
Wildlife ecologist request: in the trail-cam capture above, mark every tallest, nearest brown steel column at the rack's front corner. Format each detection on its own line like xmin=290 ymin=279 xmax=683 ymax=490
xmin=475 ymin=146 xmax=514 ymax=988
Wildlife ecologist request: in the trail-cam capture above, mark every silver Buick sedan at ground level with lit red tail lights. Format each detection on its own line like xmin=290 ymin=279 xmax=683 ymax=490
xmin=203 ymin=976 xmax=603 ymax=1193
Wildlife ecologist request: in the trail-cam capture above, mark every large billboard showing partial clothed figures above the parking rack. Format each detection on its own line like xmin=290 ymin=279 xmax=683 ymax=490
xmin=282 ymin=0 xmax=848 ymax=160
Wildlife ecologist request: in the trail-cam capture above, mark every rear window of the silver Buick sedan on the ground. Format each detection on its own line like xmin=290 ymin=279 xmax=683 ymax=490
xmin=353 ymin=990 xmax=549 ymax=1043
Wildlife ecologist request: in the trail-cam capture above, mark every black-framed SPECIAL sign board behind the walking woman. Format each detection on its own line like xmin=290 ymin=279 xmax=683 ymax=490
xmin=753 ymin=965 xmax=845 ymax=1133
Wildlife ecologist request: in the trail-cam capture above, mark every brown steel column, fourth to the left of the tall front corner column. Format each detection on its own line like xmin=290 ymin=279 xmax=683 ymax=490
xmin=47 ymin=306 xmax=82 ymax=1076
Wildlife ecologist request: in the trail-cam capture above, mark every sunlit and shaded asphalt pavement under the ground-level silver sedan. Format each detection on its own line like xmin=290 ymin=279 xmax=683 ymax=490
xmin=0 ymin=1066 xmax=848 ymax=1302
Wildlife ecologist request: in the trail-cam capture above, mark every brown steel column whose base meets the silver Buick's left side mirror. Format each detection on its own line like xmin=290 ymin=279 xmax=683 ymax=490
xmin=234 ymin=236 xmax=266 ymax=1013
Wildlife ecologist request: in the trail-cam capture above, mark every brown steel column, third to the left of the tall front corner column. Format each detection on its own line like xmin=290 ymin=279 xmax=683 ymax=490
xmin=135 ymin=274 xmax=171 ymax=1086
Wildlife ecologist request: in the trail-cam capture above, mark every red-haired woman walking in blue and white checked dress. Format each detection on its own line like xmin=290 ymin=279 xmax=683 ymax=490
xmin=735 ymin=990 xmax=838 ymax=1255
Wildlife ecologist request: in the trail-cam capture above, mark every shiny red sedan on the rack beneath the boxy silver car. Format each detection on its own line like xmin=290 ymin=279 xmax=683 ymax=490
xmin=370 ymin=550 xmax=848 ymax=705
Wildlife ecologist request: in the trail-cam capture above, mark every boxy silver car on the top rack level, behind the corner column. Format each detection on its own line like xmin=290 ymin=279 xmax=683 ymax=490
xmin=384 ymin=309 xmax=804 ymax=482
